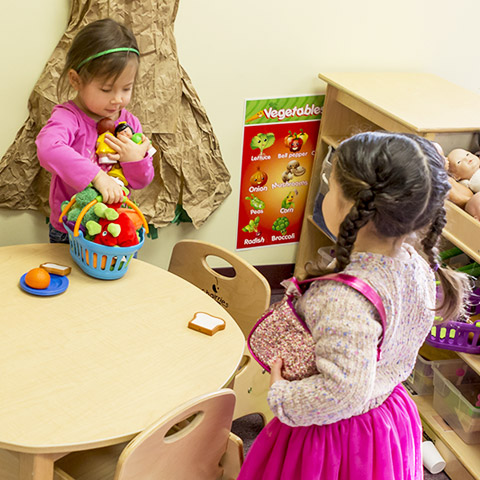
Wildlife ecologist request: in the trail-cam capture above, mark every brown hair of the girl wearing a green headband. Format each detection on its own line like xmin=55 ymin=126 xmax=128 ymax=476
xmin=57 ymin=18 xmax=139 ymax=99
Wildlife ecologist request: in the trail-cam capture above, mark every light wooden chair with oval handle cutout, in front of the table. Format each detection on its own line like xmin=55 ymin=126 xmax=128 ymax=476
xmin=55 ymin=389 xmax=243 ymax=480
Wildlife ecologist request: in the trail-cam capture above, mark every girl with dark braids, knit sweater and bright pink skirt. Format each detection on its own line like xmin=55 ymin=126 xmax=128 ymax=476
xmin=238 ymin=132 xmax=470 ymax=480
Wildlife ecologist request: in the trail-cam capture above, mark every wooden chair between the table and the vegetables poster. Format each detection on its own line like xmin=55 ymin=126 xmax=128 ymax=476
xmin=168 ymin=240 xmax=273 ymax=423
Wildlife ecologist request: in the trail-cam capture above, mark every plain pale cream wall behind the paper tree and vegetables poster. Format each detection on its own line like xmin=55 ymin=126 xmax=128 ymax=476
xmin=0 ymin=0 xmax=480 ymax=267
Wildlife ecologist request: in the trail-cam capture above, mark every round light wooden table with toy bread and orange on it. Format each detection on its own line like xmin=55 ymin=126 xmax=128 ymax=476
xmin=0 ymin=244 xmax=245 ymax=480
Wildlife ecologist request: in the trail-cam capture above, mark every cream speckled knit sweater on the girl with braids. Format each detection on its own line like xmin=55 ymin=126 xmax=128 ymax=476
xmin=268 ymin=244 xmax=435 ymax=426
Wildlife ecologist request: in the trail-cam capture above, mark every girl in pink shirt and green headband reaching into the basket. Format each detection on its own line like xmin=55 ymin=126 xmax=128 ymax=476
xmin=36 ymin=19 xmax=154 ymax=243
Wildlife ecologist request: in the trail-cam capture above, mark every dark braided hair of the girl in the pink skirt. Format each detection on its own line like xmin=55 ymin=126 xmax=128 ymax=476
xmin=312 ymin=132 xmax=469 ymax=319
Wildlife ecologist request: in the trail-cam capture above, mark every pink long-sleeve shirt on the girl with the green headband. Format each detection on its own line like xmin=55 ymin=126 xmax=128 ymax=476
xmin=36 ymin=101 xmax=154 ymax=232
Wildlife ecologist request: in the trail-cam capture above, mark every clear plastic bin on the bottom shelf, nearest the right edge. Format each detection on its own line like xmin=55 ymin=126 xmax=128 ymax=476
xmin=433 ymin=360 xmax=480 ymax=444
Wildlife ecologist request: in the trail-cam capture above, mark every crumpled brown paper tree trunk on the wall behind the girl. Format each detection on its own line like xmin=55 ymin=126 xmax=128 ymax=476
xmin=0 ymin=0 xmax=231 ymax=228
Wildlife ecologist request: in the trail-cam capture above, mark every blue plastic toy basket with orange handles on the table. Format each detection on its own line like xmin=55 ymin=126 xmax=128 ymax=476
xmin=60 ymin=197 xmax=148 ymax=280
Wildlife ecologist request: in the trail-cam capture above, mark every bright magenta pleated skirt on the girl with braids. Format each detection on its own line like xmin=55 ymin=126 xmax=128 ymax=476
xmin=237 ymin=385 xmax=423 ymax=480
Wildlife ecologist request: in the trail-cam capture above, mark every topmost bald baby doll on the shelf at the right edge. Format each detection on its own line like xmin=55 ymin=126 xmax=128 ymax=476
xmin=446 ymin=148 xmax=480 ymax=220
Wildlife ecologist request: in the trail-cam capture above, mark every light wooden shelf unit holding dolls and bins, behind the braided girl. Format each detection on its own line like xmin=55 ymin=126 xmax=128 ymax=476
xmin=295 ymin=72 xmax=480 ymax=480
